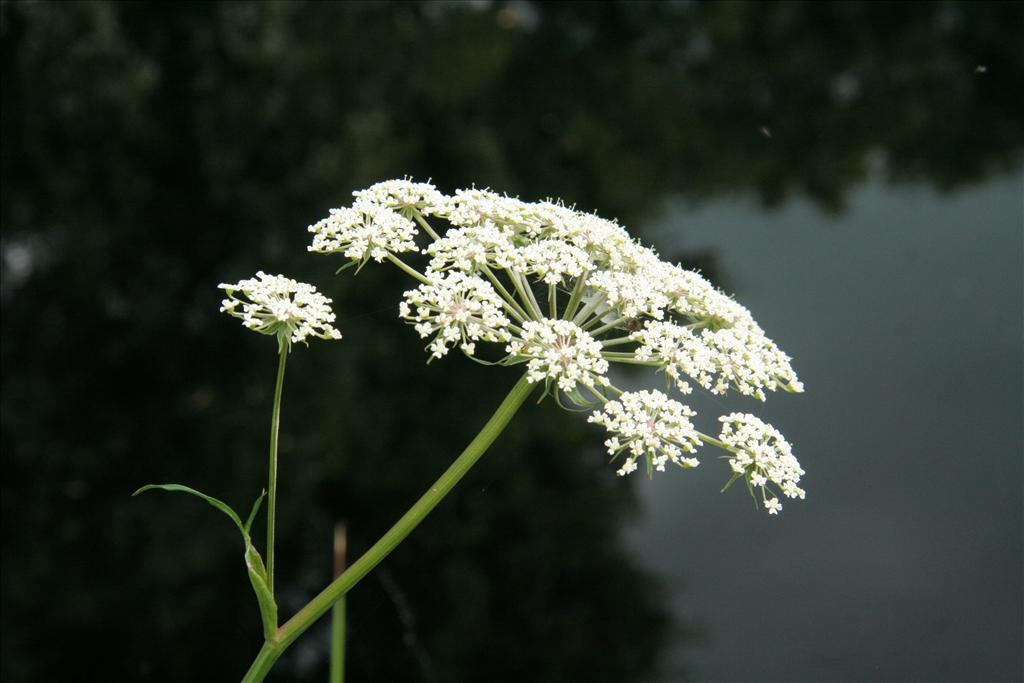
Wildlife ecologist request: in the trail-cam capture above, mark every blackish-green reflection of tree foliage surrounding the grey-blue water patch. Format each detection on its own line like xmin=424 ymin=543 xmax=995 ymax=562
xmin=0 ymin=2 xmax=1024 ymax=681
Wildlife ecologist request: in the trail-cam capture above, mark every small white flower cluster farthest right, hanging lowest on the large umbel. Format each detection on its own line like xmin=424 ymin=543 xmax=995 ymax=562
xmin=719 ymin=413 xmax=806 ymax=515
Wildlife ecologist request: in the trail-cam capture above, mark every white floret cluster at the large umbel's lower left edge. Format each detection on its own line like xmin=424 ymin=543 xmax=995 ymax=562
xmin=398 ymin=270 xmax=511 ymax=358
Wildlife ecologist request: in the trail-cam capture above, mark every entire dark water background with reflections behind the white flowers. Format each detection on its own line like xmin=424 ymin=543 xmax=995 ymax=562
xmin=0 ymin=1 xmax=1024 ymax=683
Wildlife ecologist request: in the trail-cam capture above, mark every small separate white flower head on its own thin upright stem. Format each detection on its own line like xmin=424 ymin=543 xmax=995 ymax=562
xmin=218 ymin=270 xmax=341 ymax=349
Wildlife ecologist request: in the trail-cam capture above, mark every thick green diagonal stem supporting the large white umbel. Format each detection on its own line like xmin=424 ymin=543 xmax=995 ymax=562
xmin=235 ymin=375 xmax=534 ymax=683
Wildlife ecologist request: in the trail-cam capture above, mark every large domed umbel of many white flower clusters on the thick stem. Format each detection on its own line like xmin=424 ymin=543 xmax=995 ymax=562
xmin=309 ymin=180 xmax=804 ymax=514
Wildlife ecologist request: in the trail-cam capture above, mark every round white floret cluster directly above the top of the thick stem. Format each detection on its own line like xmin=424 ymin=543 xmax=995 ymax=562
xmin=505 ymin=319 xmax=608 ymax=393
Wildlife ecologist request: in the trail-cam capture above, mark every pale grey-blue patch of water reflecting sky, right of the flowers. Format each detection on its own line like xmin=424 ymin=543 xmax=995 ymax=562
xmin=633 ymin=174 xmax=1024 ymax=681
